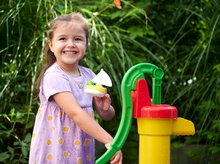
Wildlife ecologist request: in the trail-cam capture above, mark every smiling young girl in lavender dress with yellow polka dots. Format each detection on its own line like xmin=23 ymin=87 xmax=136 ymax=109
xmin=29 ymin=13 xmax=122 ymax=164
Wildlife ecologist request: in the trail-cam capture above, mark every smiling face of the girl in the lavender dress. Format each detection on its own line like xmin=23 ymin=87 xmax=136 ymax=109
xmin=48 ymin=22 xmax=87 ymax=72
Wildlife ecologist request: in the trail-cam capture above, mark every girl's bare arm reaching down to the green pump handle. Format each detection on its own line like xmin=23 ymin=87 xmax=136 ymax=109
xmin=53 ymin=92 xmax=123 ymax=164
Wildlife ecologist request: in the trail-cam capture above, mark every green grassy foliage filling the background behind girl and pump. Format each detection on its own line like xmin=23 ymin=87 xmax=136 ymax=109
xmin=0 ymin=0 xmax=220 ymax=163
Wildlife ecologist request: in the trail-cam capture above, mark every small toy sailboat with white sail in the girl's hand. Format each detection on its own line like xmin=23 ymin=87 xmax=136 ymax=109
xmin=84 ymin=69 xmax=112 ymax=97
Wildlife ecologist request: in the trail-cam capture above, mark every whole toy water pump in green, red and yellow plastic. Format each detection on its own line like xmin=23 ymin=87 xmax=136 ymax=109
xmin=96 ymin=63 xmax=195 ymax=164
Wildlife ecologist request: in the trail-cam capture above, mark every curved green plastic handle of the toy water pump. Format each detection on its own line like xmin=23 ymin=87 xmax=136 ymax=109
xmin=96 ymin=63 xmax=164 ymax=164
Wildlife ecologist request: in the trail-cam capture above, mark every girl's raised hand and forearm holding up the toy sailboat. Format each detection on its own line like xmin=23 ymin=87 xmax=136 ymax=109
xmin=93 ymin=94 xmax=115 ymax=120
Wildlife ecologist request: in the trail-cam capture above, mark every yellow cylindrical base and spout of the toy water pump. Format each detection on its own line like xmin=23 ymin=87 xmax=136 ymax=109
xmin=137 ymin=118 xmax=195 ymax=164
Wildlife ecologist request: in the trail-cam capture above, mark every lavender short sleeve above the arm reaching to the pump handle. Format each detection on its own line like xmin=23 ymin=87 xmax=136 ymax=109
xmin=42 ymin=72 xmax=71 ymax=100
